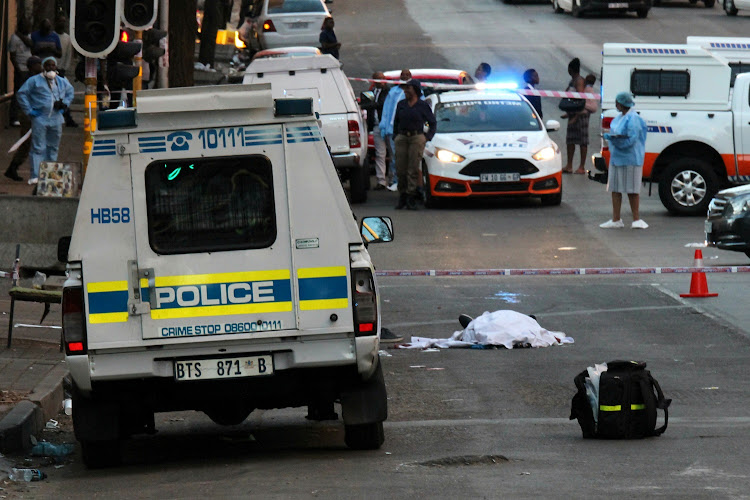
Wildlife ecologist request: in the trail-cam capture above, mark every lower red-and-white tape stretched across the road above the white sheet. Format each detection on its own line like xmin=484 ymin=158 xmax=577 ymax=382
xmin=375 ymin=266 xmax=750 ymax=277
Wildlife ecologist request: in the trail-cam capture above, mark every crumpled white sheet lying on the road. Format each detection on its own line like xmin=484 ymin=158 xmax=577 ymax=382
xmin=400 ymin=309 xmax=573 ymax=349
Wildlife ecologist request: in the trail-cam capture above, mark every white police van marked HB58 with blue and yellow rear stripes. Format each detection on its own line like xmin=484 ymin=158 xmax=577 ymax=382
xmin=58 ymin=84 xmax=393 ymax=467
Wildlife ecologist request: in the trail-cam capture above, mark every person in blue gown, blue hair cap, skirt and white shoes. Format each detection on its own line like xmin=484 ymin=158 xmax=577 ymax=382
xmin=599 ymin=92 xmax=648 ymax=229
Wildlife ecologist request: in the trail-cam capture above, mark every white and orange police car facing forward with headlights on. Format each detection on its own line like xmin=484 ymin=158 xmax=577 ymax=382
xmin=422 ymin=90 xmax=562 ymax=207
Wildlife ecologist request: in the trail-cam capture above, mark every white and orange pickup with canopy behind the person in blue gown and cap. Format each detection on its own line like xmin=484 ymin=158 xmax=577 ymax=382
xmin=594 ymin=37 xmax=750 ymax=215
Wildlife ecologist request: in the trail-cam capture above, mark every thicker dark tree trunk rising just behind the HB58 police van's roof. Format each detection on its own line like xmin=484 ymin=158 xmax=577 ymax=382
xmin=169 ymin=0 xmax=197 ymax=87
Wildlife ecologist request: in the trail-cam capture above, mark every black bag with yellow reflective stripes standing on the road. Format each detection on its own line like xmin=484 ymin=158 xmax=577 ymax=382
xmin=570 ymin=361 xmax=672 ymax=439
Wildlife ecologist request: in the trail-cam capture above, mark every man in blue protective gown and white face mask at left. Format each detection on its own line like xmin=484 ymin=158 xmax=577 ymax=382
xmin=18 ymin=57 xmax=73 ymax=184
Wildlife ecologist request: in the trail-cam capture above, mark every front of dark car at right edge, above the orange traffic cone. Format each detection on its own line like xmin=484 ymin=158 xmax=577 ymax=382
xmin=705 ymin=184 xmax=750 ymax=257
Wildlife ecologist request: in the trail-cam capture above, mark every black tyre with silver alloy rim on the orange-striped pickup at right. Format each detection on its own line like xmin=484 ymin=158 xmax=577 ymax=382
xmin=659 ymin=158 xmax=719 ymax=215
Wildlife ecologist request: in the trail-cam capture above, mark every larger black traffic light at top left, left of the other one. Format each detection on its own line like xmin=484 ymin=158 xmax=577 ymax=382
xmin=70 ymin=0 xmax=122 ymax=58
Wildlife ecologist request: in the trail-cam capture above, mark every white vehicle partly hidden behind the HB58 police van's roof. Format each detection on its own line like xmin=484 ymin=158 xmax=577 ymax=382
xmin=242 ymin=54 xmax=370 ymax=203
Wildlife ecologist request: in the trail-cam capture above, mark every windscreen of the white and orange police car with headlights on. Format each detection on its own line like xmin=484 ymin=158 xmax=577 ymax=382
xmin=435 ymin=99 xmax=542 ymax=134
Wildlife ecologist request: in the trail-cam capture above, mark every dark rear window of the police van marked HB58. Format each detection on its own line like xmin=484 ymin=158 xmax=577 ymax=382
xmin=145 ymin=155 xmax=276 ymax=254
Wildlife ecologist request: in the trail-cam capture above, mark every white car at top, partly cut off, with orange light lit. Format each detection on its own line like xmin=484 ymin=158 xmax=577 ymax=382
xmin=249 ymin=0 xmax=331 ymax=50
